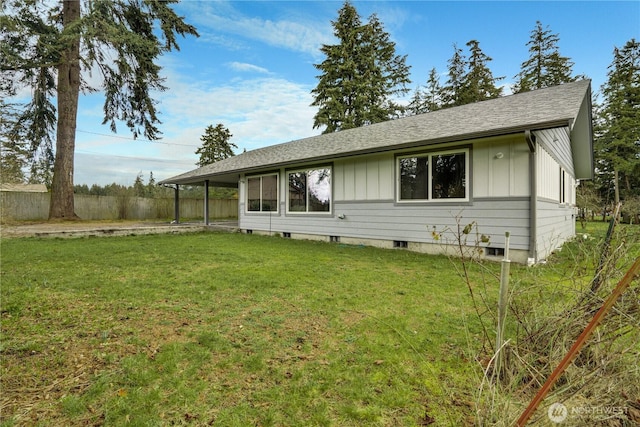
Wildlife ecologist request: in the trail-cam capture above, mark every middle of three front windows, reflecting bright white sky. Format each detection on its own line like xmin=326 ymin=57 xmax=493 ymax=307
xmin=287 ymin=167 xmax=331 ymax=212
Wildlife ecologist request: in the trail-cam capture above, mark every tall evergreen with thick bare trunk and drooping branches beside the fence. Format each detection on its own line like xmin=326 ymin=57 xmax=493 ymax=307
xmin=0 ymin=0 xmax=197 ymax=218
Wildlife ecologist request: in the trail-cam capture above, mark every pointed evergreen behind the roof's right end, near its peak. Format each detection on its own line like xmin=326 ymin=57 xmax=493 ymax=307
xmin=513 ymin=21 xmax=576 ymax=93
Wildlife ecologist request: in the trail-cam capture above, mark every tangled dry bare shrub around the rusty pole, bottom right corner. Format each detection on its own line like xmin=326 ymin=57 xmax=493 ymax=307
xmin=500 ymin=228 xmax=640 ymax=426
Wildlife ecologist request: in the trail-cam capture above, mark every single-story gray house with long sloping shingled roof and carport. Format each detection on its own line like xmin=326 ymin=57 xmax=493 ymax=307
xmin=160 ymin=80 xmax=594 ymax=263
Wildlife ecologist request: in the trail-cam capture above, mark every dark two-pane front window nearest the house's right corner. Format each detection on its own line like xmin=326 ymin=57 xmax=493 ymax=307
xmin=398 ymin=149 xmax=469 ymax=202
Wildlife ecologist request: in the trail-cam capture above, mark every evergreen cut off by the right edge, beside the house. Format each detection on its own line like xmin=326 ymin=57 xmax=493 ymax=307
xmin=595 ymin=39 xmax=640 ymax=203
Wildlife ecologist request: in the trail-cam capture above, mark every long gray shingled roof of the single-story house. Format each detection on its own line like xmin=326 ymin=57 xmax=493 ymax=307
xmin=160 ymin=80 xmax=592 ymax=185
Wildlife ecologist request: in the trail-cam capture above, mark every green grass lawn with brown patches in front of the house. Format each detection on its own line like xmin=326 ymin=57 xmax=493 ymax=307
xmin=0 ymin=227 xmax=636 ymax=426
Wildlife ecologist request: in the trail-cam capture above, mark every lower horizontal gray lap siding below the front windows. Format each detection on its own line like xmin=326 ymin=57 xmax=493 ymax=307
xmin=240 ymin=198 xmax=529 ymax=263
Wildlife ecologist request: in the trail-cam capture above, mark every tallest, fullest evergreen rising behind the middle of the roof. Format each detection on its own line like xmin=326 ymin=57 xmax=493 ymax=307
xmin=311 ymin=1 xmax=410 ymax=133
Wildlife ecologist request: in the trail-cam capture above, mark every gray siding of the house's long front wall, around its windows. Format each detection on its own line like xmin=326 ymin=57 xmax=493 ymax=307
xmin=239 ymin=136 xmax=530 ymax=262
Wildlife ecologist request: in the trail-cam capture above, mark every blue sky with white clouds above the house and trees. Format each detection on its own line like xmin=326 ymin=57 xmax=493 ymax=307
xmin=66 ymin=0 xmax=640 ymax=185
